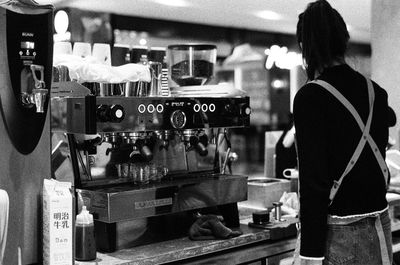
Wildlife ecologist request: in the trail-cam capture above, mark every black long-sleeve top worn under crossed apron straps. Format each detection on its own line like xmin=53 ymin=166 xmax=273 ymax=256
xmin=293 ymin=64 xmax=388 ymax=257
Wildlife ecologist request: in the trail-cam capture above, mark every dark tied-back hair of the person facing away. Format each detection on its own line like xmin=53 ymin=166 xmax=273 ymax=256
xmin=296 ymin=0 xmax=350 ymax=80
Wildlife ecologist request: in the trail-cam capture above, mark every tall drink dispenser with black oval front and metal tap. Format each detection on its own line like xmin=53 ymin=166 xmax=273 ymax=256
xmin=0 ymin=0 xmax=53 ymax=264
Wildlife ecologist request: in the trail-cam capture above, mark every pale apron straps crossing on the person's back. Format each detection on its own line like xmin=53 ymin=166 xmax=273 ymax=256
xmin=310 ymin=78 xmax=388 ymax=205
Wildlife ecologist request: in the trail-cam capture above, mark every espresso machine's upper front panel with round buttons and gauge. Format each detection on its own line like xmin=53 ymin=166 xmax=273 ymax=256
xmin=52 ymin=93 xmax=251 ymax=134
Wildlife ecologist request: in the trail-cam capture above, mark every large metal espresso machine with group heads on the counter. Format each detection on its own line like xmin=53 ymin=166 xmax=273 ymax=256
xmin=51 ymin=42 xmax=251 ymax=252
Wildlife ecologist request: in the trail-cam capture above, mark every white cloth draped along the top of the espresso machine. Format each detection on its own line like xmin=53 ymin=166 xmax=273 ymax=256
xmin=53 ymin=55 xmax=151 ymax=84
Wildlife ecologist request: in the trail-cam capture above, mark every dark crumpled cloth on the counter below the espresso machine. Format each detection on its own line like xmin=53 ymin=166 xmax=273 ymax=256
xmin=189 ymin=215 xmax=243 ymax=240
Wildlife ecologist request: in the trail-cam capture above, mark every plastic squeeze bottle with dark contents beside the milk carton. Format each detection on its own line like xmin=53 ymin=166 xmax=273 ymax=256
xmin=75 ymin=206 xmax=96 ymax=261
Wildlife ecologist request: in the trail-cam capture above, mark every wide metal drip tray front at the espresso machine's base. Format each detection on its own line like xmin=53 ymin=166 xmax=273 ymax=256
xmin=76 ymin=174 xmax=247 ymax=223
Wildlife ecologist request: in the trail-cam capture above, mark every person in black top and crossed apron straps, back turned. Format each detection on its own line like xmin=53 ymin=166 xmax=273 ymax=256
xmin=294 ymin=0 xmax=392 ymax=265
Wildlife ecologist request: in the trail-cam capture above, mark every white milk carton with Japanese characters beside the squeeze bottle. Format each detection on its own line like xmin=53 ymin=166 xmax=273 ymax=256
xmin=43 ymin=179 xmax=74 ymax=265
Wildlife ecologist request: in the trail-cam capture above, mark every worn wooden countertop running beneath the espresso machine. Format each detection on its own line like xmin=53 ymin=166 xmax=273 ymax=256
xmin=76 ymin=224 xmax=295 ymax=265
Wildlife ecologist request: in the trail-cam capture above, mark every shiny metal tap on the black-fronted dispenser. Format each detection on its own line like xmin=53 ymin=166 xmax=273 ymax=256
xmin=30 ymin=64 xmax=48 ymax=113
